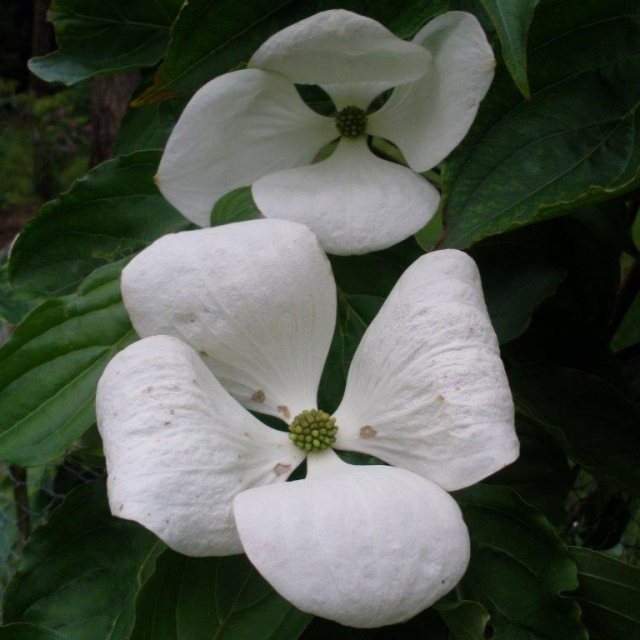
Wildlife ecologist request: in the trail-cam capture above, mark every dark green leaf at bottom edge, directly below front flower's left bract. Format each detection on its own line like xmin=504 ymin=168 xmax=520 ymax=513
xmin=131 ymin=550 xmax=312 ymax=640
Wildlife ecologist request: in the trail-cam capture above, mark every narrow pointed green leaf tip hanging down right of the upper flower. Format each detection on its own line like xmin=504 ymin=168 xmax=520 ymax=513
xmin=481 ymin=0 xmax=539 ymax=98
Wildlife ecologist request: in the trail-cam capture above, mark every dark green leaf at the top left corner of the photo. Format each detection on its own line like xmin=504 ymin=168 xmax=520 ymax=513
xmin=29 ymin=0 xmax=182 ymax=85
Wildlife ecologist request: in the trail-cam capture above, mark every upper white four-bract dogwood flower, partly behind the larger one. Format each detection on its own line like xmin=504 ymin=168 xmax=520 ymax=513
xmin=157 ymin=10 xmax=494 ymax=254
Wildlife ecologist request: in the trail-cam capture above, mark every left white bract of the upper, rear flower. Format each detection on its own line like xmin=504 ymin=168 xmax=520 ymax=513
xmin=156 ymin=69 xmax=338 ymax=227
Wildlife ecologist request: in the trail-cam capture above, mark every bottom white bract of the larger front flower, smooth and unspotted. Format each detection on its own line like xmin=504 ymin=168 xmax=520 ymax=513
xmin=234 ymin=451 xmax=469 ymax=627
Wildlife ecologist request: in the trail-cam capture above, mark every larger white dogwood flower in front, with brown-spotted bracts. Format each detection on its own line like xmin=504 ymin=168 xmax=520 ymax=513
xmin=97 ymin=220 xmax=518 ymax=627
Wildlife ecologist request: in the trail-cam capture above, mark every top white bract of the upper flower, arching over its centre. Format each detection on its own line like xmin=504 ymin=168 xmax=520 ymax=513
xmin=249 ymin=9 xmax=430 ymax=108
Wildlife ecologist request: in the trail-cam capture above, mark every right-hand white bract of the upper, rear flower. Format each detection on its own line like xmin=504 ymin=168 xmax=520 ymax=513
xmin=369 ymin=11 xmax=495 ymax=172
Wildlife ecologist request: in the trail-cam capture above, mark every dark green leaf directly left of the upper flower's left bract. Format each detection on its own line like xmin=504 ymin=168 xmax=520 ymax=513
xmin=9 ymin=151 xmax=190 ymax=294
